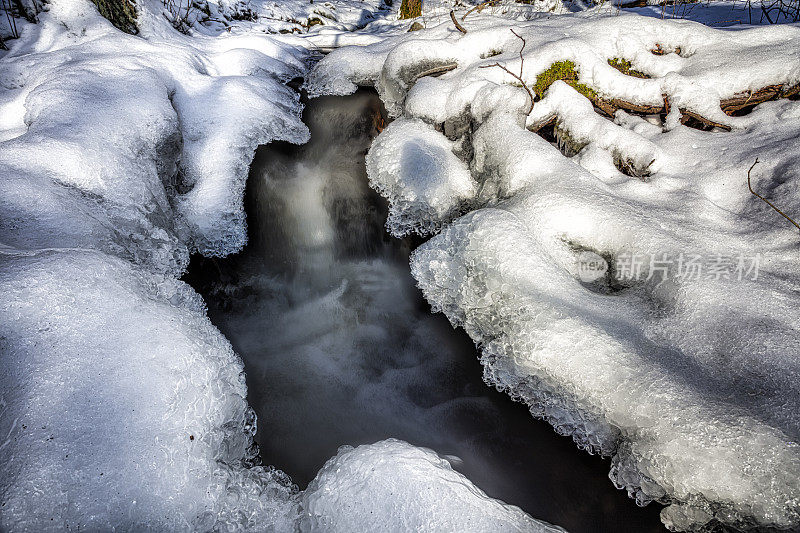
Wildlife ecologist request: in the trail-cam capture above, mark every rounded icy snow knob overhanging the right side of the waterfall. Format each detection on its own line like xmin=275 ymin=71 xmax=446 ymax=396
xmin=367 ymin=119 xmax=476 ymax=237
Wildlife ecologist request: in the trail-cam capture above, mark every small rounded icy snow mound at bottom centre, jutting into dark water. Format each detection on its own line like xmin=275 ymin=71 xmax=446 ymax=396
xmin=300 ymin=439 xmax=564 ymax=533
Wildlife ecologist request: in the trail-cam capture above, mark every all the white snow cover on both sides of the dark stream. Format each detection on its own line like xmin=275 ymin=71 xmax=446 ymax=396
xmin=0 ymin=0 xmax=800 ymax=531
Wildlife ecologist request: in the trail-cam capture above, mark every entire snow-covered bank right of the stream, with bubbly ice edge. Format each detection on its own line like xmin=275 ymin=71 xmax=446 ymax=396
xmin=311 ymin=13 xmax=800 ymax=530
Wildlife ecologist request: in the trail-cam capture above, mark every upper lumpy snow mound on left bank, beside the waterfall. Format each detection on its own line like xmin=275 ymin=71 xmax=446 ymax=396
xmin=0 ymin=0 xmax=308 ymax=266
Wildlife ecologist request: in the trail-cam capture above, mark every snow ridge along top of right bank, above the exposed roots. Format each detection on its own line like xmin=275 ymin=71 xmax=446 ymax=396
xmin=310 ymin=13 xmax=800 ymax=128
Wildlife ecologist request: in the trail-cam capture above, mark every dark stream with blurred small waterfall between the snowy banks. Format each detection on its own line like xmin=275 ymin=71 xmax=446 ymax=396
xmin=186 ymin=91 xmax=664 ymax=533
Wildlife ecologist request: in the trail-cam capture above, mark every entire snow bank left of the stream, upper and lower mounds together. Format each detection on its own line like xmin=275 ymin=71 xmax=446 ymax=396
xmin=0 ymin=0 xmax=307 ymax=530
